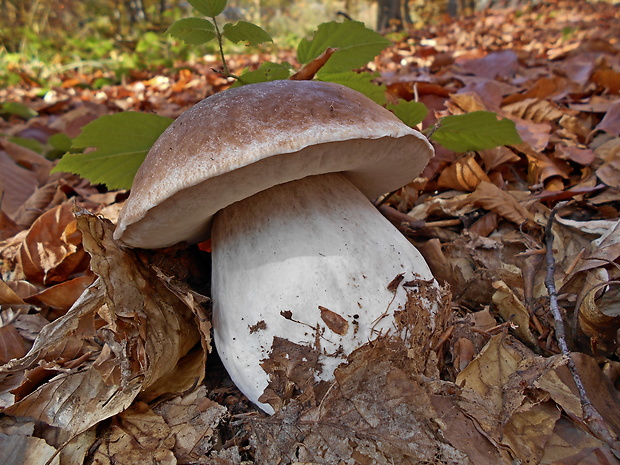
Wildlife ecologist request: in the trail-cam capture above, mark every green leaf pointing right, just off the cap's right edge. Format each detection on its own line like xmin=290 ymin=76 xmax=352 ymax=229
xmin=431 ymin=111 xmax=522 ymax=152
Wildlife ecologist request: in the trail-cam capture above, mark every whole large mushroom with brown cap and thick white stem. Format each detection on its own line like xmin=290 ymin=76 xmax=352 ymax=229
xmin=115 ymin=81 xmax=433 ymax=413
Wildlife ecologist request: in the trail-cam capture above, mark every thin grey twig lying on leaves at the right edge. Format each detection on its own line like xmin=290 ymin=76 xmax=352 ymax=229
xmin=545 ymin=202 xmax=618 ymax=449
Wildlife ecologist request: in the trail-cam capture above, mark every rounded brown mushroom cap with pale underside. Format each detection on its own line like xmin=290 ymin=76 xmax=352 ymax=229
xmin=115 ymin=81 xmax=433 ymax=248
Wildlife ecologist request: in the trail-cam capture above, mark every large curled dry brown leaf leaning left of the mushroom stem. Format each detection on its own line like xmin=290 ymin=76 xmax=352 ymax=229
xmin=0 ymin=212 xmax=206 ymax=439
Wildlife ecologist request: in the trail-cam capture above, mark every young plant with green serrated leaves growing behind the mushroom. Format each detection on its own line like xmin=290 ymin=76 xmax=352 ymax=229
xmin=54 ymin=6 xmax=521 ymax=189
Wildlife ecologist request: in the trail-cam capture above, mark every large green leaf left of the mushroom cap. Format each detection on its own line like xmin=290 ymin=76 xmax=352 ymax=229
xmin=52 ymin=112 xmax=172 ymax=189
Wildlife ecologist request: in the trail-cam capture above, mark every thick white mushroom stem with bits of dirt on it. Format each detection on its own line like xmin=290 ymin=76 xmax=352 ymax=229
xmin=212 ymin=174 xmax=433 ymax=413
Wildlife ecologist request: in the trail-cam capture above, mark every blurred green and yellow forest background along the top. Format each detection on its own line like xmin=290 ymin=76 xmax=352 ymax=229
xmin=0 ymin=0 xmax=518 ymax=85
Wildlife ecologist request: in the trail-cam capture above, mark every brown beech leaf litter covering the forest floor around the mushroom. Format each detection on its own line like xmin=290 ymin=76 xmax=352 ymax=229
xmin=0 ymin=0 xmax=620 ymax=465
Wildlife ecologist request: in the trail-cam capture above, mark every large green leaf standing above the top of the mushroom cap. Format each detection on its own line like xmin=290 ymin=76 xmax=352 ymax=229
xmin=297 ymin=21 xmax=391 ymax=77
